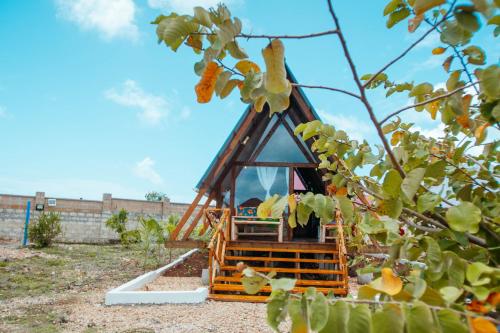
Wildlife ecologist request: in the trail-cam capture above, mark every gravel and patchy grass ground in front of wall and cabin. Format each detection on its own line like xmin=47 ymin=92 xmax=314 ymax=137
xmin=0 ymin=241 xmax=278 ymax=333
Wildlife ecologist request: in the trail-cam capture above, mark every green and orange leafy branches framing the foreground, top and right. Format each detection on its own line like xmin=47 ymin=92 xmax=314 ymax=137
xmin=154 ymin=0 xmax=500 ymax=332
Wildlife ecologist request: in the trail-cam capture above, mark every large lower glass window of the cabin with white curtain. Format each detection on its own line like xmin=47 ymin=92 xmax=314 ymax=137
xmin=234 ymin=166 xmax=289 ymax=207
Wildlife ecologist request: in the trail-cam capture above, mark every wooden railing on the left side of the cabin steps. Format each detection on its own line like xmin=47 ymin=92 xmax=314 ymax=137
xmin=204 ymin=208 xmax=231 ymax=291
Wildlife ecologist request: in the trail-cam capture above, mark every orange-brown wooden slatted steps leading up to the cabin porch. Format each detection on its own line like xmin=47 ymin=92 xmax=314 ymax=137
xmin=209 ymin=241 xmax=348 ymax=302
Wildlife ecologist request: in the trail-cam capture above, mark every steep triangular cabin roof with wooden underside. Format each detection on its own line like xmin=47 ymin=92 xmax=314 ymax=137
xmin=196 ymin=64 xmax=320 ymax=195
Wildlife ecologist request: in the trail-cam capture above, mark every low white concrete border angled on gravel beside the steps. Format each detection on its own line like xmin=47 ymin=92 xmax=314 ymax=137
xmin=104 ymin=249 xmax=208 ymax=305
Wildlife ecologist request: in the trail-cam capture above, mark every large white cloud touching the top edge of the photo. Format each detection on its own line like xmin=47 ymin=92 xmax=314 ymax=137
xmin=56 ymin=0 xmax=139 ymax=40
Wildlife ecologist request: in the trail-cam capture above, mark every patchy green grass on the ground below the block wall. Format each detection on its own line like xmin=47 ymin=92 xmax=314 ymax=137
xmin=0 ymin=244 xmax=186 ymax=333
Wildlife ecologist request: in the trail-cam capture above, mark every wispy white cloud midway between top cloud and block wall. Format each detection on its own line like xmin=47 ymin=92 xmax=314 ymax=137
xmin=105 ymin=80 xmax=170 ymax=125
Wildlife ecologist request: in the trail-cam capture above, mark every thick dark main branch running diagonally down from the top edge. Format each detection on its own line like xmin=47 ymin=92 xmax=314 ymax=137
xmin=327 ymin=0 xmax=406 ymax=178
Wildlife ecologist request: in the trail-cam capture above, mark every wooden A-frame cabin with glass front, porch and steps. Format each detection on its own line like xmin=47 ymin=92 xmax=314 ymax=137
xmin=170 ymin=67 xmax=347 ymax=301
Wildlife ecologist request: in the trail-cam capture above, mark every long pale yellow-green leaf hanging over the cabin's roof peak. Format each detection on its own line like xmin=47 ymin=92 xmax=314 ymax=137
xmin=262 ymin=39 xmax=289 ymax=94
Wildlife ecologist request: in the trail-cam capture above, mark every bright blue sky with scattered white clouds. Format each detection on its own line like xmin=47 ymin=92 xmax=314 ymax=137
xmin=0 ymin=0 xmax=500 ymax=202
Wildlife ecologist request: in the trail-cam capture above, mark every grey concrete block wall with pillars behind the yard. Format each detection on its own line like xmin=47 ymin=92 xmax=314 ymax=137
xmin=0 ymin=192 xmax=200 ymax=243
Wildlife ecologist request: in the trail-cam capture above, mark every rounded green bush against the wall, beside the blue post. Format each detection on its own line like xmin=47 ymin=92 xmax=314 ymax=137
xmin=29 ymin=212 xmax=62 ymax=247
